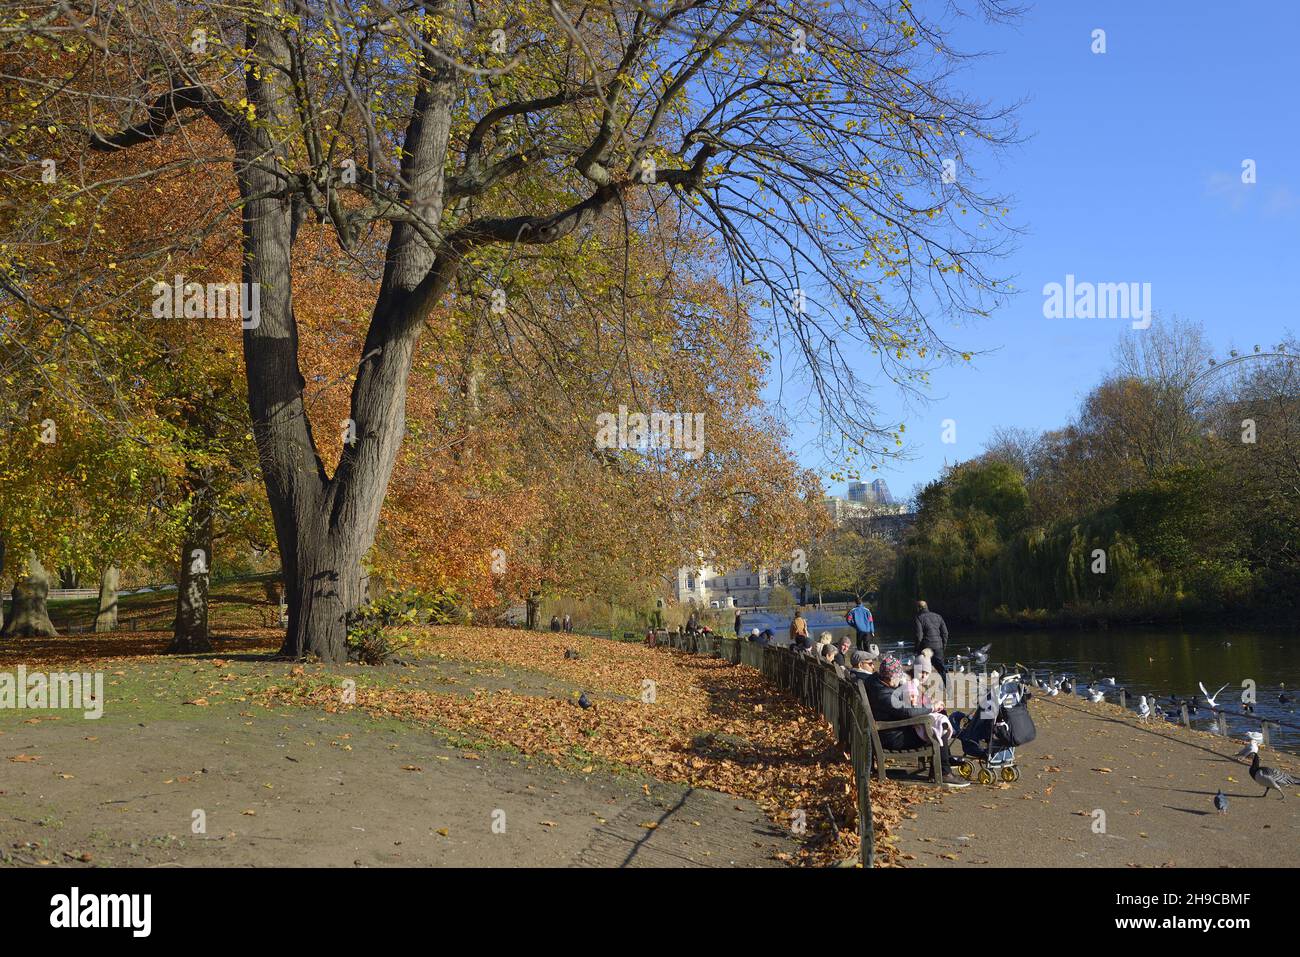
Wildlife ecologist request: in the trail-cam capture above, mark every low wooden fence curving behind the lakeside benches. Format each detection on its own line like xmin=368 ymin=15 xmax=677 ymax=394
xmin=655 ymin=631 xmax=875 ymax=867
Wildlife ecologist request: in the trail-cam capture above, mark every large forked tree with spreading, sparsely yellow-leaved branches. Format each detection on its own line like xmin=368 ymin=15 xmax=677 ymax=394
xmin=5 ymin=0 xmax=1013 ymax=661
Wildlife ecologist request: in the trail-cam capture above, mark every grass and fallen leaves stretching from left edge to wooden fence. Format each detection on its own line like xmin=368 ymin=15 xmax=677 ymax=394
xmin=0 ymin=627 xmax=936 ymax=866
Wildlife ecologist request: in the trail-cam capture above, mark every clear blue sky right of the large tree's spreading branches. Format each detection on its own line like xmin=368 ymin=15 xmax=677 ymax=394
xmin=770 ymin=0 xmax=1300 ymax=504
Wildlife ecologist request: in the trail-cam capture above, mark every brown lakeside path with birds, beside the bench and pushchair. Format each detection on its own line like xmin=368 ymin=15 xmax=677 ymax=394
xmin=898 ymin=696 xmax=1300 ymax=867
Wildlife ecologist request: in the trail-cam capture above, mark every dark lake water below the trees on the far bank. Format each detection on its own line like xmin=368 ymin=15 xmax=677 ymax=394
xmin=742 ymin=609 xmax=1300 ymax=753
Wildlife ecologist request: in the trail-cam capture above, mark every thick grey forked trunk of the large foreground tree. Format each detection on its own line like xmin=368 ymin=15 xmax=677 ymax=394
xmin=235 ymin=16 xmax=459 ymax=662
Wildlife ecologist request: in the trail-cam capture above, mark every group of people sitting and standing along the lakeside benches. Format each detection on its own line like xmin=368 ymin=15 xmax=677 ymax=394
xmin=736 ymin=599 xmax=970 ymax=788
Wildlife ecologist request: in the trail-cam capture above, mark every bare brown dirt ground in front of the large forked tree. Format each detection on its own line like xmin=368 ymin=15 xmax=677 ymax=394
xmin=0 ymin=709 xmax=793 ymax=867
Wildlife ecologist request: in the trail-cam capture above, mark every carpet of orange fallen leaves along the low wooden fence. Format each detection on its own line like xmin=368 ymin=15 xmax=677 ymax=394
xmin=265 ymin=627 xmax=933 ymax=865
